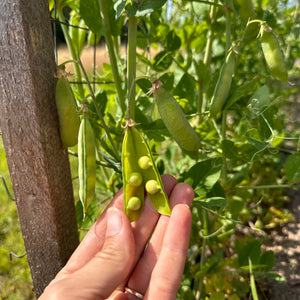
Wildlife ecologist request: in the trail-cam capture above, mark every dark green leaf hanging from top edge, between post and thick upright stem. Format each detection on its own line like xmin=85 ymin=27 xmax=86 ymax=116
xmin=79 ymin=0 xmax=105 ymax=35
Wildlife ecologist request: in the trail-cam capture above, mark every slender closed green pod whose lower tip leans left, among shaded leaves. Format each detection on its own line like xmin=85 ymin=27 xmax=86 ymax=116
xmin=210 ymin=49 xmax=236 ymax=119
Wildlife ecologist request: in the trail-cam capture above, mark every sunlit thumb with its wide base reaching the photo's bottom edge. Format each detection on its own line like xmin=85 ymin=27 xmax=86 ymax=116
xmin=41 ymin=208 xmax=134 ymax=300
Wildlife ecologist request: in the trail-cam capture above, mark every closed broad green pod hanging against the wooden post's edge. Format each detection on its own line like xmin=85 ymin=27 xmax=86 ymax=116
xmin=55 ymin=70 xmax=80 ymax=148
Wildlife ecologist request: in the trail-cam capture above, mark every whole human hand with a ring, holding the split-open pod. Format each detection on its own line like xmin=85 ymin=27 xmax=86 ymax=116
xmin=39 ymin=175 xmax=194 ymax=300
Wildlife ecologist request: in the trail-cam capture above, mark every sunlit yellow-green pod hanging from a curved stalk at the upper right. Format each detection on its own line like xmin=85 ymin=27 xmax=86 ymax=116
xmin=260 ymin=22 xmax=288 ymax=81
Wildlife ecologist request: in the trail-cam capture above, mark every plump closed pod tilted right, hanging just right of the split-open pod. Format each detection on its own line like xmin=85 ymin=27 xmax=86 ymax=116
xmin=151 ymin=80 xmax=200 ymax=152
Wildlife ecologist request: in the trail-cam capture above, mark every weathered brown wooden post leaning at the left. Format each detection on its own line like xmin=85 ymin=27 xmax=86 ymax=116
xmin=0 ymin=0 xmax=79 ymax=297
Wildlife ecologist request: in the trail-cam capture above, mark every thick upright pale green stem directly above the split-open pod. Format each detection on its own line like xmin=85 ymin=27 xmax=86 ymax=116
xmin=127 ymin=16 xmax=137 ymax=120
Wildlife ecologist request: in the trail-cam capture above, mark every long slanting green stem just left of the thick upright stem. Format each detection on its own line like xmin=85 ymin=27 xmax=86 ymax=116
xmin=100 ymin=0 xmax=126 ymax=115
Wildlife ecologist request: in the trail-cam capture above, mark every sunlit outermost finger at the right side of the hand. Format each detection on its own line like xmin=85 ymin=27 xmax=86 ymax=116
xmin=144 ymin=204 xmax=192 ymax=300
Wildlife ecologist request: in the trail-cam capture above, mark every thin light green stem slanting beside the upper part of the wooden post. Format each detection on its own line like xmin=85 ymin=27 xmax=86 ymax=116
xmin=57 ymin=5 xmax=84 ymax=98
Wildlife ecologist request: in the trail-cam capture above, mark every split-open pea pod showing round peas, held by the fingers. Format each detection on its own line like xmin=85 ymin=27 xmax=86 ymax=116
xmin=122 ymin=119 xmax=171 ymax=222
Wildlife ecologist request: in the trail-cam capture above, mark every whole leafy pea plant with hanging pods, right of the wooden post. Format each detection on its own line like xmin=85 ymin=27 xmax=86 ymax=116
xmin=49 ymin=0 xmax=300 ymax=299
